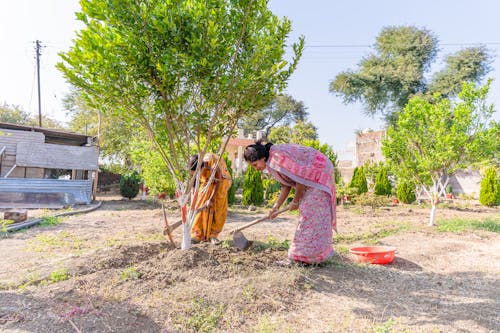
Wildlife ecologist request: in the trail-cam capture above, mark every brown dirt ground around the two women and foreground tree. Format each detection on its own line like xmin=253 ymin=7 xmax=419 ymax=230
xmin=0 ymin=196 xmax=500 ymax=333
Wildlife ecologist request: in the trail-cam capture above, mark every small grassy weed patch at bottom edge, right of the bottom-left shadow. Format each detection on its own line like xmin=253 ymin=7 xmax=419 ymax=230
xmin=178 ymin=298 xmax=225 ymax=332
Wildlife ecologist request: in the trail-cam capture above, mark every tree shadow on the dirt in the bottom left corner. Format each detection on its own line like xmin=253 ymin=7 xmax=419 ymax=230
xmin=0 ymin=290 xmax=161 ymax=333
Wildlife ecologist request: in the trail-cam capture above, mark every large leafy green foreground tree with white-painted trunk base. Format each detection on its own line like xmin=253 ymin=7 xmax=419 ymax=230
xmin=58 ymin=0 xmax=303 ymax=249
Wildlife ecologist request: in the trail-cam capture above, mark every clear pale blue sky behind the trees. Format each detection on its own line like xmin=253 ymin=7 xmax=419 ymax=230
xmin=0 ymin=0 xmax=500 ymax=155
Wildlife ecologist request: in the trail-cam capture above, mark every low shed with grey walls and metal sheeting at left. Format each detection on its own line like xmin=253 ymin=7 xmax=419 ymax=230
xmin=0 ymin=123 xmax=98 ymax=208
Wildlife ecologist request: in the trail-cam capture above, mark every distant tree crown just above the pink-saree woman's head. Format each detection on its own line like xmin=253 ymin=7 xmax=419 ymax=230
xmin=238 ymin=95 xmax=308 ymax=138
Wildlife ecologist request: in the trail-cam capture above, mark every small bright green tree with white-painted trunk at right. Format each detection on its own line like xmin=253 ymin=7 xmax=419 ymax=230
xmin=382 ymin=83 xmax=499 ymax=226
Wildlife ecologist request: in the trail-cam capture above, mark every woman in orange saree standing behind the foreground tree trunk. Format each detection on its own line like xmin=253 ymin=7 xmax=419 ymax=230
xmin=191 ymin=153 xmax=231 ymax=244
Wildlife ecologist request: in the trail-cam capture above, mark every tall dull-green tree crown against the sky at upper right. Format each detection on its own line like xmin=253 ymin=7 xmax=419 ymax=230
xmin=329 ymin=26 xmax=491 ymax=123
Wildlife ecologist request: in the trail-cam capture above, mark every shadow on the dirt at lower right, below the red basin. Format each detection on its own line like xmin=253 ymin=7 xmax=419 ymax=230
xmin=310 ymin=256 xmax=500 ymax=332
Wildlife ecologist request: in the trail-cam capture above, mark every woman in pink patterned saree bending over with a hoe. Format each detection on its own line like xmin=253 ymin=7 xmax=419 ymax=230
xmin=244 ymin=141 xmax=337 ymax=264
